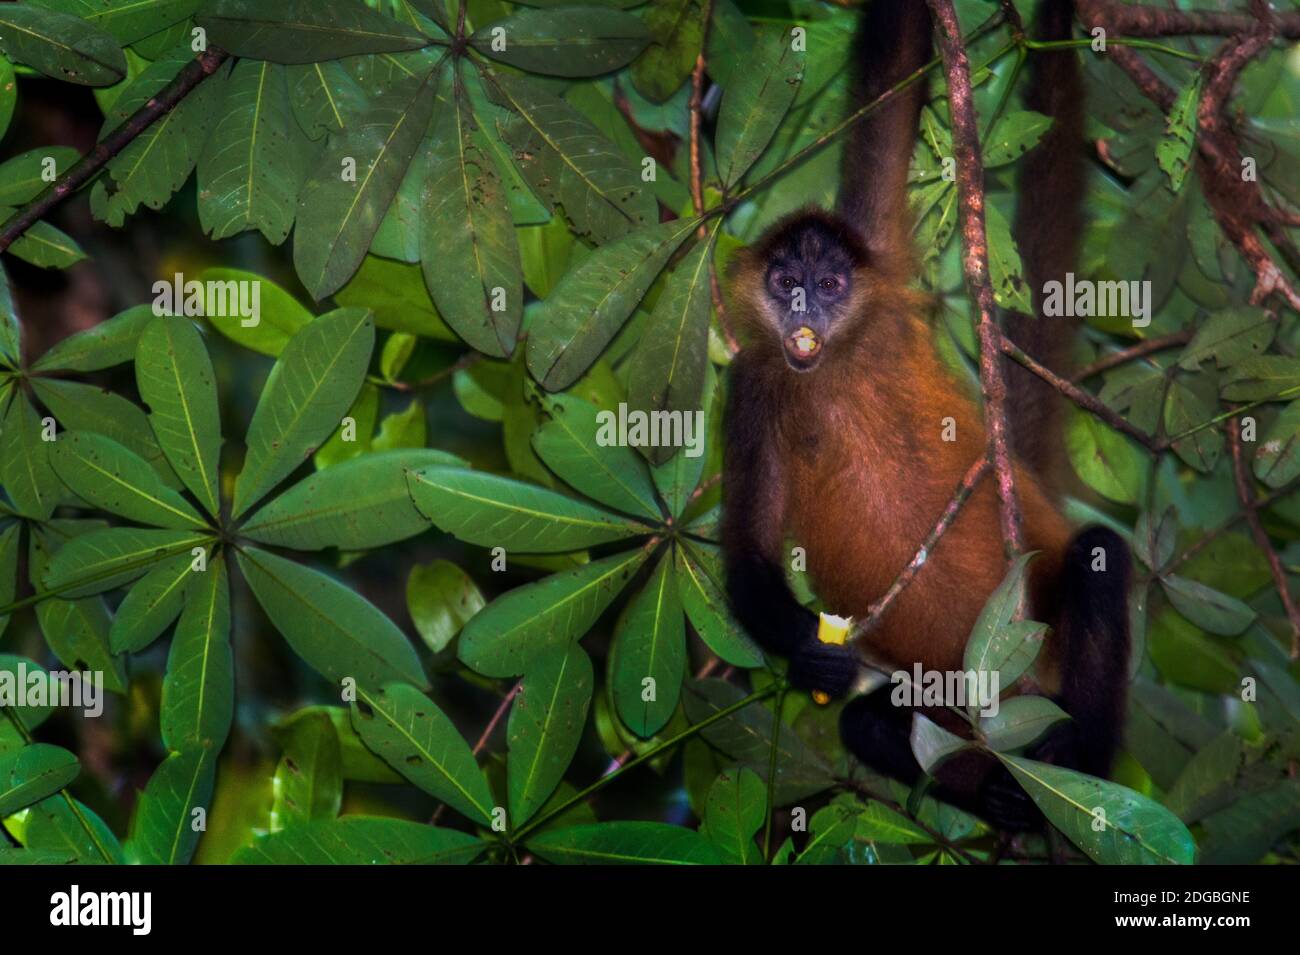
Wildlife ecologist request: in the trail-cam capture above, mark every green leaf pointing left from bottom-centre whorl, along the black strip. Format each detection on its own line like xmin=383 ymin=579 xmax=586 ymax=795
xmin=230 ymin=816 xmax=484 ymax=865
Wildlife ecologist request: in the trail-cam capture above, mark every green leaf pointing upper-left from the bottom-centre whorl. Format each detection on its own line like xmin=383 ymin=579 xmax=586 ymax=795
xmin=352 ymin=683 xmax=495 ymax=825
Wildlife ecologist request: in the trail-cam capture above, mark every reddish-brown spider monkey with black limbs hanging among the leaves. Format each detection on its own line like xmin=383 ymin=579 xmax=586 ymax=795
xmin=723 ymin=0 xmax=1130 ymax=829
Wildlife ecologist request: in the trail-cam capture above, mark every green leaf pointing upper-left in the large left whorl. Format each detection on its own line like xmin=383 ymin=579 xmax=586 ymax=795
xmin=49 ymin=431 xmax=207 ymax=529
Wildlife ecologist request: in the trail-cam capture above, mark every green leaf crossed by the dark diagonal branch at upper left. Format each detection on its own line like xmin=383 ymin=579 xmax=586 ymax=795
xmin=90 ymin=48 xmax=229 ymax=227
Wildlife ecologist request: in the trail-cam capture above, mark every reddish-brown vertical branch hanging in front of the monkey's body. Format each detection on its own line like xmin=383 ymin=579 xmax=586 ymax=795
xmin=927 ymin=0 xmax=1024 ymax=557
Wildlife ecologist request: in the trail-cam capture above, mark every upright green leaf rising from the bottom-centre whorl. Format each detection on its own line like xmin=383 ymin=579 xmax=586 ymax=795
xmin=506 ymin=643 xmax=594 ymax=829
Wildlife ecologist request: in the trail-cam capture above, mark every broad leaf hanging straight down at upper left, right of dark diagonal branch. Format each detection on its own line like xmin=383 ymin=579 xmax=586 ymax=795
xmin=199 ymin=60 xmax=306 ymax=246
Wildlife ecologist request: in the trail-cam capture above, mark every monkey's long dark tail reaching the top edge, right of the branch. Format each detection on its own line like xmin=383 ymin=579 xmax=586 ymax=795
xmin=1006 ymin=0 xmax=1086 ymax=491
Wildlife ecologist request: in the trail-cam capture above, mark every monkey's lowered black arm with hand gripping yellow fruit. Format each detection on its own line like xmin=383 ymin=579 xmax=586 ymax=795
xmin=723 ymin=355 xmax=858 ymax=695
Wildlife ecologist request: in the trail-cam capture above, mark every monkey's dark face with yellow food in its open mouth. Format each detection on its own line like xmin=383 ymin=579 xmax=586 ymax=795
xmin=758 ymin=213 xmax=863 ymax=372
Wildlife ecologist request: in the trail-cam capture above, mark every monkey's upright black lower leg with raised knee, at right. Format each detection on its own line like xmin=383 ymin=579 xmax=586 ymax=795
xmin=1035 ymin=526 xmax=1131 ymax=778
